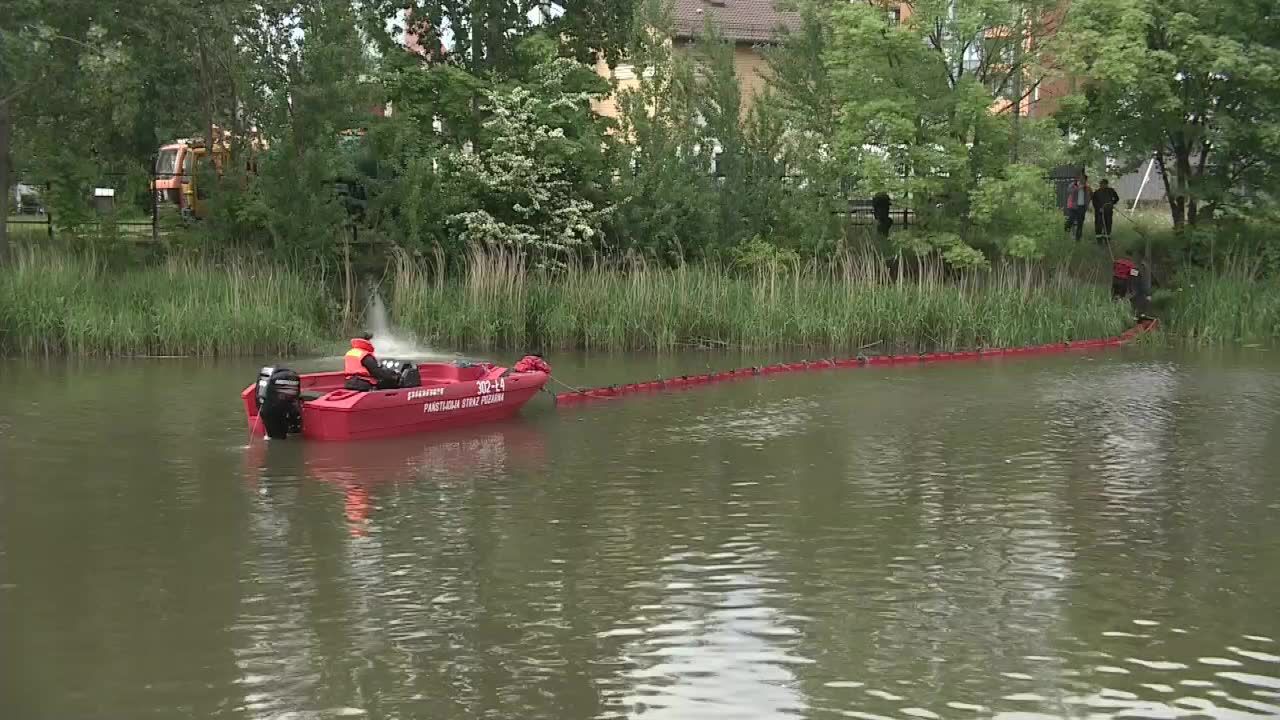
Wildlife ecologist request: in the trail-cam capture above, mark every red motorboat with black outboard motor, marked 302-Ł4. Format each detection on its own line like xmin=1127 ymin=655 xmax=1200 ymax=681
xmin=241 ymin=357 xmax=549 ymax=439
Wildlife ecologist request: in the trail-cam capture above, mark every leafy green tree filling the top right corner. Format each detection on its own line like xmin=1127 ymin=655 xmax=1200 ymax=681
xmin=1062 ymin=0 xmax=1280 ymax=227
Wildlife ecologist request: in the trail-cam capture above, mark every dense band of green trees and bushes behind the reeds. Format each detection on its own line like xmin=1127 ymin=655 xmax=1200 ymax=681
xmin=0 ymin=0 xmax=1280 ymax=353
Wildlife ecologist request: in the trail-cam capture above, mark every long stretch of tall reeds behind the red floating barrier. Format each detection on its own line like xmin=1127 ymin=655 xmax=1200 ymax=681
xmin=392 ymin=254 xmax=1130 ymax=351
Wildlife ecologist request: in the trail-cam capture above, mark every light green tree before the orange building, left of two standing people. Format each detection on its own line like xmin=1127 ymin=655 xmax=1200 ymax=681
xmin=826 ymin=0 xmax=1059 ymax=232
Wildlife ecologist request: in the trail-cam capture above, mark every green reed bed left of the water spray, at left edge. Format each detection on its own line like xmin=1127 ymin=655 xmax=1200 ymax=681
xmin=0 ymin=251 xmax=338 ymax=356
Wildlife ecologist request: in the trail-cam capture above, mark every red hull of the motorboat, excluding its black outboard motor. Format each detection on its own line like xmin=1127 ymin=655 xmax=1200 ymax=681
xmin=241 ymin=364 xmax=548 ymax=441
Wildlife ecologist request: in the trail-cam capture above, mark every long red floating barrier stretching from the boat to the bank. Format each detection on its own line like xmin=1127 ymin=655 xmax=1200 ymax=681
xmin=556 ymin=319 xmax=1157 ymax=405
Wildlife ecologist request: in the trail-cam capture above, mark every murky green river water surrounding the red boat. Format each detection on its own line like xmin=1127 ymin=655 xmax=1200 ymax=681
xmin=0 ymin=350 xmax=1280 ymax=720
